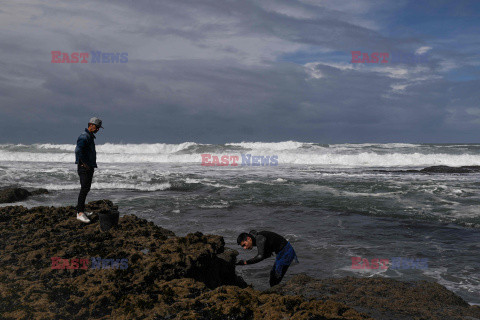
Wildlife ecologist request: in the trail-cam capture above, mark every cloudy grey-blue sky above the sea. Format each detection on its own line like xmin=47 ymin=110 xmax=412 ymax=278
xmin=0 ymin=0 xmax=480 ymax=144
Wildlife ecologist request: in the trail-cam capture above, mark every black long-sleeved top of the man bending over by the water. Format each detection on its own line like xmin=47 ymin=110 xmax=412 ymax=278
xmin=247 ymin=230 xmax=288 ymax=264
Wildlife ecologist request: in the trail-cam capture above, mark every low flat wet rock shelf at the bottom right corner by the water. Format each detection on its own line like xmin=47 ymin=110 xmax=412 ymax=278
xmin=269 ymin=275 xmax=480 ymax=320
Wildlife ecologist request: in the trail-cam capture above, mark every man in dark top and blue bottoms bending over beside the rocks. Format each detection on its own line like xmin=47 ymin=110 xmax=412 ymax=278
xmin=237 ymin=230 xmax=298 ymax=287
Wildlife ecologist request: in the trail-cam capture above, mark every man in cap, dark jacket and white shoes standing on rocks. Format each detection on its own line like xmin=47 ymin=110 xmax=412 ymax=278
xmin=75 ymin=117 xmax=103 ymax=223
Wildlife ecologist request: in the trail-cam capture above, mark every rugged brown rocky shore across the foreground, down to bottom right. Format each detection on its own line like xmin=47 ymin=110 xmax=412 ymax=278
xmin=0 ymin=200 xmax=480 ymax=320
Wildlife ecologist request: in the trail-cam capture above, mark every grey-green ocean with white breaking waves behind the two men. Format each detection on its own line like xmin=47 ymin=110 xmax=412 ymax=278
xmin=0 ymin=141 xmax=480 ymax=305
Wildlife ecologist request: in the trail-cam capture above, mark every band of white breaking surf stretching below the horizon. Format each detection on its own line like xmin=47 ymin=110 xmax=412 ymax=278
xmin=0 ymin=141 xmax=480 ymax=168
